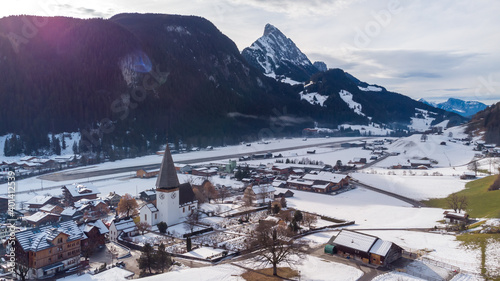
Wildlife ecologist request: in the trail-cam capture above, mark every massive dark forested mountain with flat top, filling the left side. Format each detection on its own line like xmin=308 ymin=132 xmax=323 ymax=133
xmin=0 ymin=14 xmax=315 ymax=156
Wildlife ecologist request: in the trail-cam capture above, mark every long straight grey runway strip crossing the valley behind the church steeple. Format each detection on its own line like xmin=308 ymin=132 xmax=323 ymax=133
xmin=39 ymin=137 xmax=372 ymax=181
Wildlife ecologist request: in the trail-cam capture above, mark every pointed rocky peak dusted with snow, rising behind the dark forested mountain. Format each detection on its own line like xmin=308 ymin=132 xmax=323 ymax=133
xmin=241 ymin=24 xmax=318 ymax=82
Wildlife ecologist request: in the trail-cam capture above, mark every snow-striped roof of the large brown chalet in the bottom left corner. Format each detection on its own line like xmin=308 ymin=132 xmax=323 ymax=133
xmin=16 ymin=221 xmax=87 ymax=252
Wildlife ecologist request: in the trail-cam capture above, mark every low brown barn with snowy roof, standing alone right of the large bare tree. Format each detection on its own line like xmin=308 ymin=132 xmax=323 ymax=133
xmin=325 ymin=229 xmax=403 ymax=266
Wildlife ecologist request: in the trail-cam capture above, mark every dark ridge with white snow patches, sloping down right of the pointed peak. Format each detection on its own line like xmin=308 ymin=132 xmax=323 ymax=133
xmin=300 ymin=69 xmax=465 ymax=131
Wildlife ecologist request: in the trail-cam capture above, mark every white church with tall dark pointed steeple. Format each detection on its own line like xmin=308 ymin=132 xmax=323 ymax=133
xmin=139 ymin=144 xmax=198 ymax=226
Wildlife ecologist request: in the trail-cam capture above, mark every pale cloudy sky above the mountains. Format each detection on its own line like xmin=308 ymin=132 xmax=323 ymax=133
xmin=0 ymin=0 xmax=500 ymax=104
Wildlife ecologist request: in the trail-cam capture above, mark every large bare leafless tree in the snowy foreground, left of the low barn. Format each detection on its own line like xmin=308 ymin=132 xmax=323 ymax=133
xmin=251 ymin=221 xmax=306 ymax=276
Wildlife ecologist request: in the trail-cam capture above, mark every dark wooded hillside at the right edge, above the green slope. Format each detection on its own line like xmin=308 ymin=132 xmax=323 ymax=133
xmin=466 ymin=102 xmax=500 ymax=146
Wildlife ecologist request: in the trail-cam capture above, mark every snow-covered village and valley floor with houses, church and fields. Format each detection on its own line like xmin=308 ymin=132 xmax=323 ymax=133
xmin=2 ymin=124 xmax=500 ymax=280
